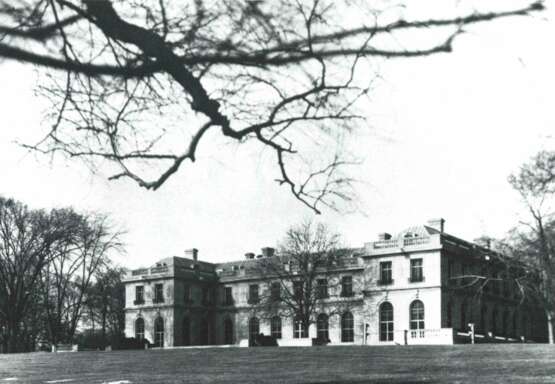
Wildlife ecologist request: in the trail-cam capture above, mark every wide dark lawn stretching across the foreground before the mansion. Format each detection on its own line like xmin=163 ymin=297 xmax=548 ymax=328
xmin=0 ymin=344 xmax=555 ymax=384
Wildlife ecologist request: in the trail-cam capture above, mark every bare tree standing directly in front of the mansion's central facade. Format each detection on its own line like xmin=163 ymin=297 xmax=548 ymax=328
xmin=253 ymin=221 xmax=356 ymax=337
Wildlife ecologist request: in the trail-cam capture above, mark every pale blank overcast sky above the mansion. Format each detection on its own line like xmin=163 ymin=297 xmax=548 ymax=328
xmin=0 ymin=1 xmax=555 ymax=268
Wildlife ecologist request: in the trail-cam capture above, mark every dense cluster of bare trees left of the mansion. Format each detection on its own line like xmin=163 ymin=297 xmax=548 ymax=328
xmin=0 ymin=197 xmax=123 ymax=352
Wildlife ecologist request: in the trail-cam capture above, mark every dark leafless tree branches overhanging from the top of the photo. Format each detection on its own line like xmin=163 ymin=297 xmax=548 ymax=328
xmin=0 ymin=0 xmax=543 ymax=213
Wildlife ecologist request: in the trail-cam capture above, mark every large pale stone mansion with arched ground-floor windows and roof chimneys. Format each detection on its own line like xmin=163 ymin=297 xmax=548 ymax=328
xmin=125 ymin=219 xmax=547 ymax=347
